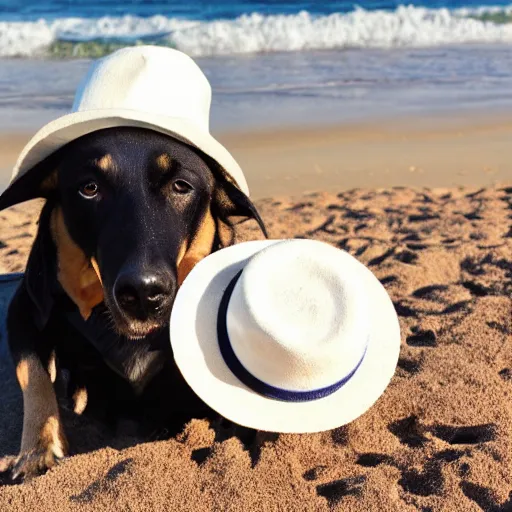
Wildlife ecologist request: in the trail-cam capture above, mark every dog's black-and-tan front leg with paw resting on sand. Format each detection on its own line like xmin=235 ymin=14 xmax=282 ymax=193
xmin=0 ymin=289 xmax=67 ymax=478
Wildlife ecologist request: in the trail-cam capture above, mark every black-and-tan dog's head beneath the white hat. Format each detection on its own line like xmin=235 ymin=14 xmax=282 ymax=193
xmin=0 ymin=128 xmax=266 ymax=338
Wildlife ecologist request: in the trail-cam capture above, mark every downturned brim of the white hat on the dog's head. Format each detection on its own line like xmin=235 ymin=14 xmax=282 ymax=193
xmin=11 ymin=109 xmax=249 ymax=195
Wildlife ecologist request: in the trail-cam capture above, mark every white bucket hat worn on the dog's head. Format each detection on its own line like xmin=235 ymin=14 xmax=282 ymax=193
xmin=6 ymin=46 xmax=249 ymax=195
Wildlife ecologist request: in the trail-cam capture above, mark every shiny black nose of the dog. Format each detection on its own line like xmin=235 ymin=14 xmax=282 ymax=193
xmin=114 ymin=272 xmax=174 ymax=320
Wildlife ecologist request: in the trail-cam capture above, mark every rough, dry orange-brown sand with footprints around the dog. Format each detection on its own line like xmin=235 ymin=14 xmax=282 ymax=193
xmin=0 ymin=185 xmax=512 ymax=512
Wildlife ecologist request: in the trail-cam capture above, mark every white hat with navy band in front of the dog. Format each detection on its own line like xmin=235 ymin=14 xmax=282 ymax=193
xmin=170 ymin=240 xmax=400 ymax=433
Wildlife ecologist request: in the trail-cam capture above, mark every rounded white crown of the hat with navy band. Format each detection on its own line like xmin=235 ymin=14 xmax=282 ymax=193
xmin=226 ymin=240 xmax=369 ymax=392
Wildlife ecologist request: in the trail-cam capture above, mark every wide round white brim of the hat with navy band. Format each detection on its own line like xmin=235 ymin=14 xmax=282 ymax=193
xmin=170 ymin=240 xmax=400 ymax=433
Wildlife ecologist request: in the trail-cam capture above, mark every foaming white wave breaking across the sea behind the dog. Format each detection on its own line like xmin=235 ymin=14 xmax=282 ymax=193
xmin=0 ymin=5 xmax=512 ymax=57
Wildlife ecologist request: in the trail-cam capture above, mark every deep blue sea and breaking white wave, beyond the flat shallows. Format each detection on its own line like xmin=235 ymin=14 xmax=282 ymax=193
xmin=0 ymin=0 xmax=512 ymax=58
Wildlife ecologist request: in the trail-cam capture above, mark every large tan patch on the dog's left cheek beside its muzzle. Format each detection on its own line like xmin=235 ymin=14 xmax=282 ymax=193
xmin=51 ymin=207 xmax=103 ymax=320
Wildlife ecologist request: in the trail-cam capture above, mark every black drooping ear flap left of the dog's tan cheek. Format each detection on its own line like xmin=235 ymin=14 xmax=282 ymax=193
xmin=23 ymin=201 xmax=57 ymax=329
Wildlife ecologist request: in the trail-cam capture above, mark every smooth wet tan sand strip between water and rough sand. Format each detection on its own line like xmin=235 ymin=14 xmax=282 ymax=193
xmin=0 ymin=112 xmax=512 ymax=199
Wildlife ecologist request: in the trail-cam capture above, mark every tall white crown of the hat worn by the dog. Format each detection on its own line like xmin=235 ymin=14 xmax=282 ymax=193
xmin=72 ymin=46 xmax=211 ymax=131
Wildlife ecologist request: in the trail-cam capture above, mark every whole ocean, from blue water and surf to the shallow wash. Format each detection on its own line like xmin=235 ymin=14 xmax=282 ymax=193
xmin=0 ymin=0 xmax=512 ymax=130
